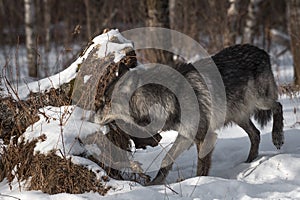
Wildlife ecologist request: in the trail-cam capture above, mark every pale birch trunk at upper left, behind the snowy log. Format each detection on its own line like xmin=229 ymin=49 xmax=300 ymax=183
xmin=24 ymin=0 xmax=38 ymax=77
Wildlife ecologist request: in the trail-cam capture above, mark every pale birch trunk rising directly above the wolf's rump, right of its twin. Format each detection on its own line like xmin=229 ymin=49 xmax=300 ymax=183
xmin=243 ymin=0 xmax=262 ymax=43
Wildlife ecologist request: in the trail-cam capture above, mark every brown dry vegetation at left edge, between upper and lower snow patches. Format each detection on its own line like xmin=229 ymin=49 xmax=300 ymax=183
xmin=0 ymin=84 xmax=71 ymax=144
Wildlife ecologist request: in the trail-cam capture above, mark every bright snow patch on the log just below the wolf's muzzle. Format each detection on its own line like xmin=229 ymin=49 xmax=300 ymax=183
xmin=24 ymin=106 xmax=100 ymax=155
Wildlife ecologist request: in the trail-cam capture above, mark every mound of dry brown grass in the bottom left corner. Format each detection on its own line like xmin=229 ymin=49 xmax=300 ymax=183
xmin=0 ymin=136 xmax=110 ymax=195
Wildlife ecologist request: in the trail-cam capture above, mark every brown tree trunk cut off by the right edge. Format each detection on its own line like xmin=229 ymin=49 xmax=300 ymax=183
xmin=287 ymin=0 xmax=300 ymax=85
